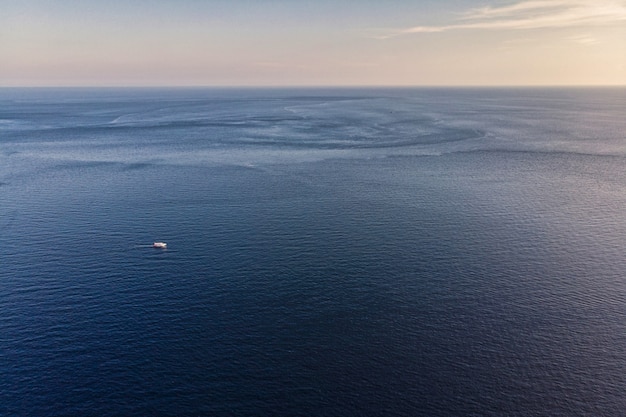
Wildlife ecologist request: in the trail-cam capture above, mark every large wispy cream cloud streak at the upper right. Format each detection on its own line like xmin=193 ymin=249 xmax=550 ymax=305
xmin=381 ymin=0 xmax=626 ymax=38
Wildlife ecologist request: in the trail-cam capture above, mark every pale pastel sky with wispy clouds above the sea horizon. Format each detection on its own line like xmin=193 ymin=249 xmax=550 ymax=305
xmin=0 ymin=0 xmax=626 ymax=86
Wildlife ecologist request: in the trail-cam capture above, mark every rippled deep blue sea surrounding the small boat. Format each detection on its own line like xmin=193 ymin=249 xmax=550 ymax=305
xmin=0 ymin=88 xmax=626 ymax=416
